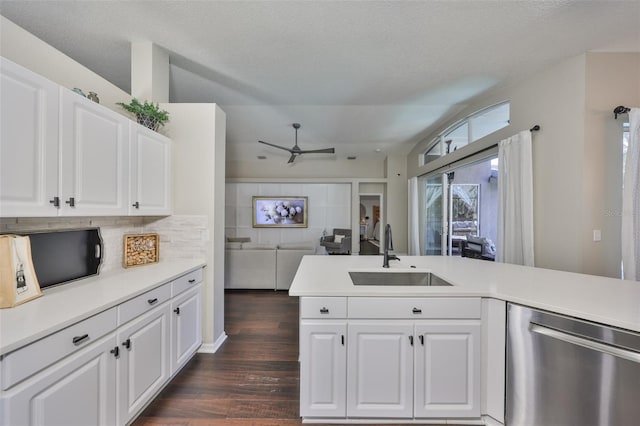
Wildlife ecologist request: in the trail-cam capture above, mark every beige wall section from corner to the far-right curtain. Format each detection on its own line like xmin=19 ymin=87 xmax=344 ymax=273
xmin=581 ymin=53 xmax=640 ymax=277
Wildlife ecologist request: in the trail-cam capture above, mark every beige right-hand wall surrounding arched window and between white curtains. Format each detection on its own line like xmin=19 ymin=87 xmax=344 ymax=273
xmin=407 ymin=53 xmax=640 ymax=277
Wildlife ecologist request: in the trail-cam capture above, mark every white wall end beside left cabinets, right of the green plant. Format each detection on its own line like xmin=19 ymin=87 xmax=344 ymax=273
xmin=161 ymin=104 xmax=226 ymax=345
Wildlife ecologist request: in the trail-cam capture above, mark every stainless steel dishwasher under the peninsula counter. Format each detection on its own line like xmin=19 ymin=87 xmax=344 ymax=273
xmin=505 ymin=303 xmax=640 ymax=426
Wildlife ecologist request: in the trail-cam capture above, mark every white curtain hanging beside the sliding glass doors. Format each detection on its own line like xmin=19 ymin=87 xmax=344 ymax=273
xmin=496 ymin=130 xmax=534 ymax=266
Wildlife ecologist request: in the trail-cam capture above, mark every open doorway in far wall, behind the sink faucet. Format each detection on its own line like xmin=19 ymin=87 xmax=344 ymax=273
xmin=359 ymin=193 xmax=384 ymax=255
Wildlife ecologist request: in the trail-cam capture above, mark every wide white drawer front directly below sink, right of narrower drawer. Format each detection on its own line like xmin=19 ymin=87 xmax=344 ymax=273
xmin=348 ymin=297 xmax=482 ymax=319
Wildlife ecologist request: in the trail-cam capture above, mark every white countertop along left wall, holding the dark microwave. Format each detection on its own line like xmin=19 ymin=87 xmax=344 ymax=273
xmin=0 ymin=259 xmax=205 ymax=355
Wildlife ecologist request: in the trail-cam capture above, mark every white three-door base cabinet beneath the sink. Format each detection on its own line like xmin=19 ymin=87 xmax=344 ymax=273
xmin=300 ymin=297 xmax=482 ymax=419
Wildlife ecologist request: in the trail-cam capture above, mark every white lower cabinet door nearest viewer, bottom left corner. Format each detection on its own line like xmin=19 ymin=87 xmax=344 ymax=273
xmin=0 ymin=334 xmax=117 ymax=426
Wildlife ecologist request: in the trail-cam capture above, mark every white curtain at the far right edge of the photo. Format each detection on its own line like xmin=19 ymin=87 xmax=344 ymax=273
xmin=622 ymin=108 xmax=640 ymax=281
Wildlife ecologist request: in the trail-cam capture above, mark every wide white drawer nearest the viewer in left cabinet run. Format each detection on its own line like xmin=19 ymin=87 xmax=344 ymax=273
xmin=0 ymin=307 xmax=117 ymax=390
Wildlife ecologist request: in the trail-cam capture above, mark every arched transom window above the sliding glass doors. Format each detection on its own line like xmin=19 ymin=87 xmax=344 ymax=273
xmin=421 ymin=102 xmax=510 ymax=165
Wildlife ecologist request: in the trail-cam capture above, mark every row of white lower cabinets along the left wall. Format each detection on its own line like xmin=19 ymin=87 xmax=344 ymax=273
xmin=0 ymin=270 xmax=202 ymax=426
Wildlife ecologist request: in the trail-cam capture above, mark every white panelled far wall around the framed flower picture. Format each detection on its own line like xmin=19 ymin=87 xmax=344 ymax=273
xmin=225 ymin=182 xmax=351 ymax=246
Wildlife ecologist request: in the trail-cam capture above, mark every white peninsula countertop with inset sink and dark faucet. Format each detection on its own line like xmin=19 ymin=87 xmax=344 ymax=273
xmin=289 ymin=256 xmax=640 ymax=332
